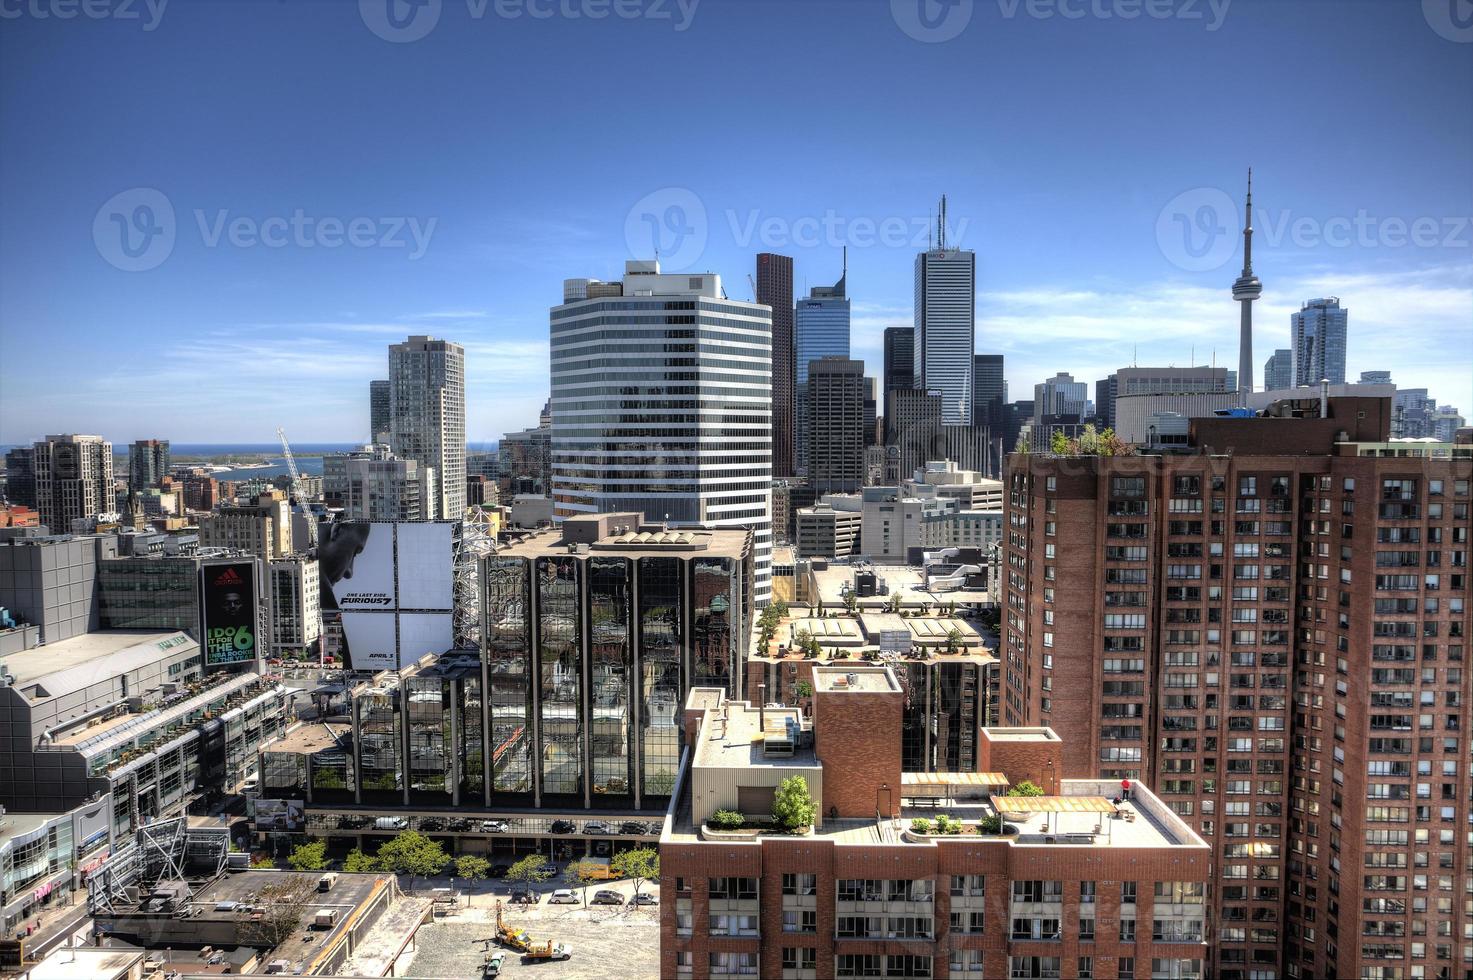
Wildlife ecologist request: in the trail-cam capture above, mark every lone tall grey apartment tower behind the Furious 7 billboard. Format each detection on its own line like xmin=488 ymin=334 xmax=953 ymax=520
xmin=389 ymin=336 xmax=465 ymax=520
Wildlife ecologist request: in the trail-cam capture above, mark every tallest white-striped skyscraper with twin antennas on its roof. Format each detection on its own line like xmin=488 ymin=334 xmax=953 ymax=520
xmin=912 ymin=196 xmax=977 ymax=424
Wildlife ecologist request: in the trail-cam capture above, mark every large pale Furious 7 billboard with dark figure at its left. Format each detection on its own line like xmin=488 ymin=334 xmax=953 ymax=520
xmin=317 ymin=522 xmax=455 ymax=671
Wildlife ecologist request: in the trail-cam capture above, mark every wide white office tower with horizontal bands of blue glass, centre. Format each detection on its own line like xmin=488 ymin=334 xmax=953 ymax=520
xmin=551 ymin=261 xmax=772 ymax=604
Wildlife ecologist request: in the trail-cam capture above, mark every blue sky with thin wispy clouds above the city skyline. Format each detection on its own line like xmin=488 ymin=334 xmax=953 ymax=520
xmin=0 ymin=0 xmax=1473 ymax=444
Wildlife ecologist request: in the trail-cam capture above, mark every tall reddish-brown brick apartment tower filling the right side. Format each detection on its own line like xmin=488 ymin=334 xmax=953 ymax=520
xmin=1002 ymin=398 xmax=1473 ymax=980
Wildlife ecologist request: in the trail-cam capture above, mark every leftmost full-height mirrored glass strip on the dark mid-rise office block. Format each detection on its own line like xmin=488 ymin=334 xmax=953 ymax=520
xmin=482 ymin=559 xmax=532 ymax=794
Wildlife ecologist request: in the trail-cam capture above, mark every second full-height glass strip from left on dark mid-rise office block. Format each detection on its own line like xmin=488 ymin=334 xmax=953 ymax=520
xmin=538 ymin=557 xmax=583 ymax=800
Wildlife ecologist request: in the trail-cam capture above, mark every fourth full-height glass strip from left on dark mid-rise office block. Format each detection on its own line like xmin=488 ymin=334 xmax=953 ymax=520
xmin=639 ymin=559 xmax=685 ymax=799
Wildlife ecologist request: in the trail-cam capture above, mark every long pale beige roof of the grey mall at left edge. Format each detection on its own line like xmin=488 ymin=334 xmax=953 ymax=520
xmin=0 ymin=629 xmax=199 ymax=692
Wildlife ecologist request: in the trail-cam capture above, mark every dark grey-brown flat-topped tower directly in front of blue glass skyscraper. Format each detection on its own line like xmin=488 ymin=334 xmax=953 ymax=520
xmin=806 ymin=357 xmax=872 ymax=497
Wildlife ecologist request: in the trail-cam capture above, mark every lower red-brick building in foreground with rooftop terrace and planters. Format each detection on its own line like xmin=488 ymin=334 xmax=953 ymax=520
xmin=660 ymin=665 xmax=1209 ymax=980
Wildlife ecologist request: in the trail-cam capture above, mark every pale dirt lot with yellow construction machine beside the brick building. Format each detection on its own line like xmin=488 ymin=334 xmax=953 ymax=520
xmin=395 ymin=886 xmax=660 ymax=980
